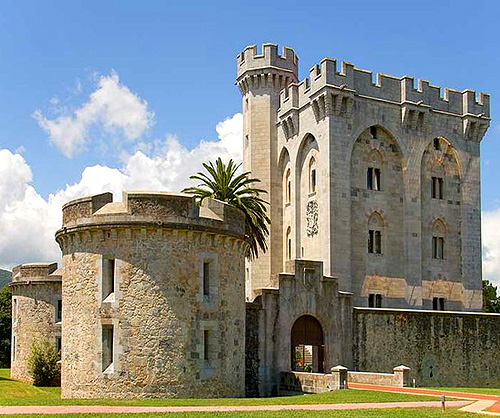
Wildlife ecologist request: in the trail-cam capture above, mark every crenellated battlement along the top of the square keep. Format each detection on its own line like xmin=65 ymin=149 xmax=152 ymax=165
xmin=280 ymin=58 xmax=490 ymax=118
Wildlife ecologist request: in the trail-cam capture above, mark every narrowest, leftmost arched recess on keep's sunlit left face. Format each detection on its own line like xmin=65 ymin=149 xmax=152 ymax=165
xmin=276 ymin=147 xmax=294 ymax=271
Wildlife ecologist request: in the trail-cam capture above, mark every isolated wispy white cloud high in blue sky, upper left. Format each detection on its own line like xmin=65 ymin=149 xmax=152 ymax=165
xmin=33 ymin=72 xmax=154 ymax=158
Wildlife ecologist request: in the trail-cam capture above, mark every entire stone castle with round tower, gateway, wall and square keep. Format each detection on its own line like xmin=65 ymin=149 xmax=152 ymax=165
xmin=12 ymin=44 xmax=500 ymax=397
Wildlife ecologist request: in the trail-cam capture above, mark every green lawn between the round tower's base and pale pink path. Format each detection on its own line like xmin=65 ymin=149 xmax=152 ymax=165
xmin=0 ymin=369 xmax=442 ymax=406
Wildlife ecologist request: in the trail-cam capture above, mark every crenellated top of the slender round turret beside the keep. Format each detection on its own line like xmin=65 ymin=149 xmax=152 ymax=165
xmin=237 ymin=44 xmax=299 ymax=79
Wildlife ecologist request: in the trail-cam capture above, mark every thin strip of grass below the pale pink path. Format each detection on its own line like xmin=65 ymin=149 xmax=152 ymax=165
xmin=2 ymin=408 xmax=478 ymax=418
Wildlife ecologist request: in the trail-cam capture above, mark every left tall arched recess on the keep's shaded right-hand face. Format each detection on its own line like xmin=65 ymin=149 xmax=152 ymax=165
xmin=349 ymin=125 xmax=406 ymax=306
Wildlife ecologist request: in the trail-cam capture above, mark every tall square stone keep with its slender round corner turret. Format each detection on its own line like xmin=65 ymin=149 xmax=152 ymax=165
xmin=238 ymin=44 xmax=490 ymax=310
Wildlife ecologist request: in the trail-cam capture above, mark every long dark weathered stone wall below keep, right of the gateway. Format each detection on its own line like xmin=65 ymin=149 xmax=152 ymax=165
xmin=353 ymin=308 xmax=500 ymax=387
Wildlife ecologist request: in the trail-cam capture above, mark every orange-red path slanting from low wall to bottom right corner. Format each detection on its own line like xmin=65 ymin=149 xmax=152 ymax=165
xmin=349 ymin=383 xmax=500 ymax=416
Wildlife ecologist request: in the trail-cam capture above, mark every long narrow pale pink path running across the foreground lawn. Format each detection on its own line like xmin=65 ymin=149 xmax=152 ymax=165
xmin=0 ymin=401 xmax=470 ymax=415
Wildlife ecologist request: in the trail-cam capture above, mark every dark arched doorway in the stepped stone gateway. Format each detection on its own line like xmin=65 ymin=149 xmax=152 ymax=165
xmin=291 ymin=315 xmax=325 ymax=373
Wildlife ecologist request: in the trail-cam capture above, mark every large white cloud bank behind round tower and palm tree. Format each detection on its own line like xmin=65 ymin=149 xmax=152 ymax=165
xmin=0 ymin=113 xmax=243 ymax=269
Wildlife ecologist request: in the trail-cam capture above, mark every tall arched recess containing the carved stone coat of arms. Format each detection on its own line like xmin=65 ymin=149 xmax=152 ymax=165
xmin=295 ymin=134 xmax=318 ymax=259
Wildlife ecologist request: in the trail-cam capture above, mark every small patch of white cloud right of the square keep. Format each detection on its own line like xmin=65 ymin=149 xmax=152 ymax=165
xmin=482 ymin=209 xmax=500 ymax=286
